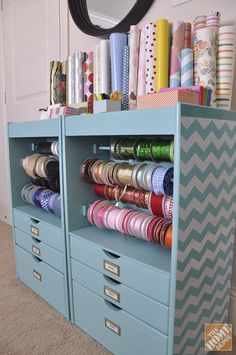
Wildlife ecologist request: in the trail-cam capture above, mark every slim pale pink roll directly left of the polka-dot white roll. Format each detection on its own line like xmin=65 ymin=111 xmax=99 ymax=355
xmin=137 ymin=28 xmax=146 ymax=95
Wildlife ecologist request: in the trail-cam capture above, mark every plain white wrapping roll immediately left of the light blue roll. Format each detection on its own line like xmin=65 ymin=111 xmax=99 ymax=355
xmin=100 ymin=39 xmax=111 ymax=95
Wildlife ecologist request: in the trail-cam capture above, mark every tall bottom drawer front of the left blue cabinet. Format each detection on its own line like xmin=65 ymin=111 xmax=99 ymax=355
xmin=15 ymin=245 xmax=65 ymax=315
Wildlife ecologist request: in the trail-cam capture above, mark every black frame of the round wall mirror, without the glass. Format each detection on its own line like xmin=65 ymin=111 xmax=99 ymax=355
xmin=68 ymin=0 xmax=154 ymax=37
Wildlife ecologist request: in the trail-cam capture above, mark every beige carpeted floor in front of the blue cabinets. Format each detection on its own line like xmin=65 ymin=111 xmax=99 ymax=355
xmin=0 ymin=222 xmax=236 ymax=355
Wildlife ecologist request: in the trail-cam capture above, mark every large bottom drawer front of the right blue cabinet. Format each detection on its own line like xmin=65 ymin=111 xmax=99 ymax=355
xmin=73 ymin=282 xmax=168 ymax=355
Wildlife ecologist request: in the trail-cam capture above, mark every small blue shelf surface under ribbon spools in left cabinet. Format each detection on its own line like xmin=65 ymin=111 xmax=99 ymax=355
xmin=14 ymin=204 xmax=61 ymax=228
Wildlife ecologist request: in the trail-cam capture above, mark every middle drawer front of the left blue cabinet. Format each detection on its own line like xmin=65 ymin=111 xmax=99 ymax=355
xmin=15 ymin=228 xmax=64 ymax=273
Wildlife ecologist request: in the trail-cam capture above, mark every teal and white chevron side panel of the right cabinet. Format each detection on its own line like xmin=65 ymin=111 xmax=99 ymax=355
xmin=174 ymin=117 xmax=236 ymax=355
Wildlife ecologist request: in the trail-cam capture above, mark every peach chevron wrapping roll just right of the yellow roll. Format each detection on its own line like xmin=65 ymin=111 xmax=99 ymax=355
xmin=170 ymin=21 xmax=185 ymax=88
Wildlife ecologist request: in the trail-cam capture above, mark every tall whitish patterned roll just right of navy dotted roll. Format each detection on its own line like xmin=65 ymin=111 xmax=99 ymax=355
xmin=129 ymin=25 xmax=140 ymax=110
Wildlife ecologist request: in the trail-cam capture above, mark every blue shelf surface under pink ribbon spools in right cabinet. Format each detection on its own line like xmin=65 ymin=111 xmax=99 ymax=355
xmin=70 ymin=226 xmax=171 ymax=274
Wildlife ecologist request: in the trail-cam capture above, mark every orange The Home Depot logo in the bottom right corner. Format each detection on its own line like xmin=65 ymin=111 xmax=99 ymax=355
xmin=205 ymin=323 xmax=232 ymax=351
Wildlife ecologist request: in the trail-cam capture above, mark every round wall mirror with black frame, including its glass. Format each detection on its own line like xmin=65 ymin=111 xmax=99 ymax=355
xmin=68 ymin=0 xmax=154 ymax=37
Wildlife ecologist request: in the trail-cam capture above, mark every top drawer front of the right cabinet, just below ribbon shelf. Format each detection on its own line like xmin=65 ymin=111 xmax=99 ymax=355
xmin=70 ymin=235 xmax=169 ymax=305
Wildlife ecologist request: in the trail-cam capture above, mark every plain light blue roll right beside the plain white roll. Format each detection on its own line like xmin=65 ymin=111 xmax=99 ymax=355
xmin=110 ymin=33 xmax=127 ymax=92
